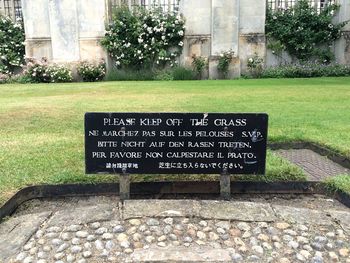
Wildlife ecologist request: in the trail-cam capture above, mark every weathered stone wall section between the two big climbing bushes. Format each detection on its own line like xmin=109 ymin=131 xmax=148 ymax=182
xmin=180 ymin=0 xmax=266 ymax=79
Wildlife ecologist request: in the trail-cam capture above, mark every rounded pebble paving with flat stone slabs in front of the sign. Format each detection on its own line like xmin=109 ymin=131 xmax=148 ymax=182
xmin=0 ymin=201 xmax=350 ymax=263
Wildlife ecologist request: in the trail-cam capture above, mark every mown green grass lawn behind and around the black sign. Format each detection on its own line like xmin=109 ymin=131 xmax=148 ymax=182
xmin=0 ymin=78 xmax=350 ymax=204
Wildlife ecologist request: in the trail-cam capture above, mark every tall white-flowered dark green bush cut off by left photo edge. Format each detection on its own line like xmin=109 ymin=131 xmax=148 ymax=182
xmin=0 ymin=16 xmax=25 ymax=75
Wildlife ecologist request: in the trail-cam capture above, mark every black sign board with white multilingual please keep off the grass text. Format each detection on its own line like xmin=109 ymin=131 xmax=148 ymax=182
xmin=85 ymin=113 xmax=268 ymax=174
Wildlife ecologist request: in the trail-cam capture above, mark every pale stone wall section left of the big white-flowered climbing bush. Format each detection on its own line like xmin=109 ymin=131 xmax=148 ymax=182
xmin=22 ymin=0 xmax=106 ymax=63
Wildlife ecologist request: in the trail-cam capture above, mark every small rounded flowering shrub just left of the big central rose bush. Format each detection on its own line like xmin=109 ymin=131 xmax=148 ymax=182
xmin=77 ymin=61 xmax=106 ymax=82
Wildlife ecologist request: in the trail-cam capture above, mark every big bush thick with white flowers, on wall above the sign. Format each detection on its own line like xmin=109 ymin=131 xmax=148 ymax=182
xmin=102 ymin=7 xmax=185 ymax=69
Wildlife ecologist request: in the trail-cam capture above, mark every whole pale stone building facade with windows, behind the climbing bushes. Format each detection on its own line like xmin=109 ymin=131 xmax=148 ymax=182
xmin=0 ymin=0 xmax=350 ymax=78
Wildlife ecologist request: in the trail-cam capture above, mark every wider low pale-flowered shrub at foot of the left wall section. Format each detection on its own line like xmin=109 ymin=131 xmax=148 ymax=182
xmin=26 ymin=58 xmax=73 ymax=83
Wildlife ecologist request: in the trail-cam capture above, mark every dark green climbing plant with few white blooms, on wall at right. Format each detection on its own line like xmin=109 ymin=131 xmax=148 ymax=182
xmin=266 ymin=0 xmax=347 ymax=63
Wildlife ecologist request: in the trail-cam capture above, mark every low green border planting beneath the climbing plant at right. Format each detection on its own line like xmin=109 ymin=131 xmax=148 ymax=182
xmin=260 ymin=63 xmax=350 ymax=78
